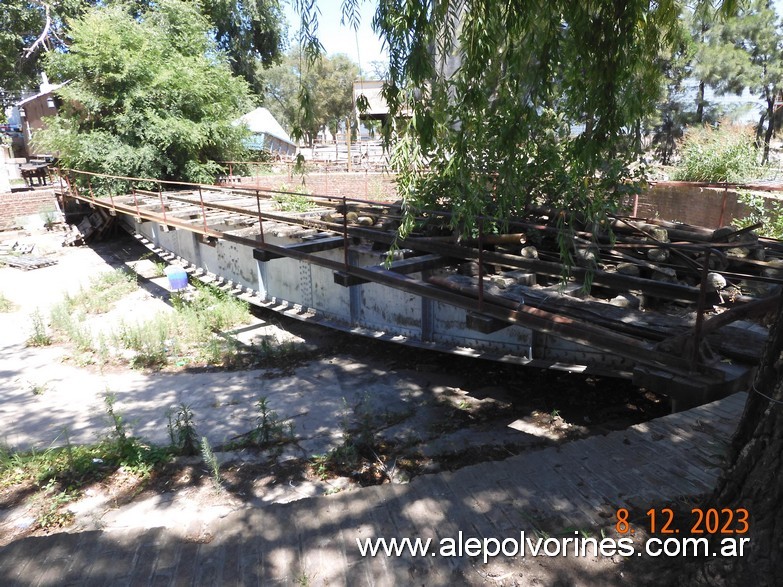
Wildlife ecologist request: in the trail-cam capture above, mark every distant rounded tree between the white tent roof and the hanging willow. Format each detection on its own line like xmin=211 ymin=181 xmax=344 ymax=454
xmin=264 ymin=49 xmax=359 ymax=144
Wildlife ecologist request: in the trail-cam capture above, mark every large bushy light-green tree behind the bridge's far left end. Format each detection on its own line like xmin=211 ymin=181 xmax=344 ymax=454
xmin=34 ymin=0 xmax=249 ymax=181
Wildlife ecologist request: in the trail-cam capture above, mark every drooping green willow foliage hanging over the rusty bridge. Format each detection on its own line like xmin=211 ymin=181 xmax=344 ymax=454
xmin=362 ymin=0 xmax=678 ymax=247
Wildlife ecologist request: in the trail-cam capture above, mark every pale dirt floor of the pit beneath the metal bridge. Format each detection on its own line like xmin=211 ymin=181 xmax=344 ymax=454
xmin=0 ymin=230 xmax=669 ymax=584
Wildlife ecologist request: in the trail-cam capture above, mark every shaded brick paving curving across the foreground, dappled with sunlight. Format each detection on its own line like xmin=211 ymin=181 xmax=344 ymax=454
xmin=0 ymin=393 xmax=746 ymax=585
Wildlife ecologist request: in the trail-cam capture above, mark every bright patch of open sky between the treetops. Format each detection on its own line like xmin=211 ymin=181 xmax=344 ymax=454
xmin=283 ymin=0 xmax=388 ymax=74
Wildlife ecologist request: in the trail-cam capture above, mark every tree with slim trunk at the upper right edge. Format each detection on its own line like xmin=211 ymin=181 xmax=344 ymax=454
xmin=697 ymin=0 xmax=783 ymax=164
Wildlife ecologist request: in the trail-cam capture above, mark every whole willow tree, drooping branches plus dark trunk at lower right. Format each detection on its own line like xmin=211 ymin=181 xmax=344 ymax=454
xmin=297 ymin=0 xmax=783 ymax=585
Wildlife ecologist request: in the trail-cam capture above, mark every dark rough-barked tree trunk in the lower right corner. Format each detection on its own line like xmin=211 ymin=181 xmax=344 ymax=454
xmin=683 ymin=296 xmax=783 ymax=585
